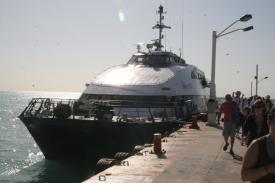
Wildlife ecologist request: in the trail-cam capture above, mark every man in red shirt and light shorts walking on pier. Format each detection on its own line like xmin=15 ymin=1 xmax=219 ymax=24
xmin=218 ymin=94 xmax=237 ymax=155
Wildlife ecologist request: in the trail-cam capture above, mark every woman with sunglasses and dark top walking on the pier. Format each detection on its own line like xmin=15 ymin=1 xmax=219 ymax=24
xmin=243 ymin=99 xmax=268 ymax=146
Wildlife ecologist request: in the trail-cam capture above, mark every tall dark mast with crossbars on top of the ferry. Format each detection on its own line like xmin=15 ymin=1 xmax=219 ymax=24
xmin=153 ymin=5 xmax=171 ymax=51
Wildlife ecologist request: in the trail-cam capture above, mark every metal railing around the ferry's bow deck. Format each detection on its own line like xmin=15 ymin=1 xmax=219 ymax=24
xmin=20 ymin=98 xmax=192 ymax=122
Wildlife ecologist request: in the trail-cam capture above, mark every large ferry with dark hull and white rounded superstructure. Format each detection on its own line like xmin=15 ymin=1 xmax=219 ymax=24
xmin=19 ymin=5 xmax=209 ymax=160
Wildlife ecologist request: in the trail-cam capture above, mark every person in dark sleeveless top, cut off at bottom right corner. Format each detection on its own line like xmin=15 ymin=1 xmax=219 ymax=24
xmin=241 ymin=107 xmax=275 ymax=183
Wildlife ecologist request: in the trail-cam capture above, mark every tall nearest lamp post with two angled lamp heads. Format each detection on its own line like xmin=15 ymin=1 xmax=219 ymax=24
xmin=207 ymin=14 xmax=253 ymax=126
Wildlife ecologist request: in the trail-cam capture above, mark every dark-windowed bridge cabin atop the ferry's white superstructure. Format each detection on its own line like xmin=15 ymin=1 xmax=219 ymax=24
xmin=127 ymin=51 xmax=187 ymax=67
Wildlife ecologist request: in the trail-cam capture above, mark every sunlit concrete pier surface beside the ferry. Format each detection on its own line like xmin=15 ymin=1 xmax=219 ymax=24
xmin=85 ymin=123 xmax=246 ymax=183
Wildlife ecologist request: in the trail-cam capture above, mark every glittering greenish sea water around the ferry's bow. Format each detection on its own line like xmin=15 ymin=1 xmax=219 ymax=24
xmin=0 ymin=91 xmax=97 ymax=183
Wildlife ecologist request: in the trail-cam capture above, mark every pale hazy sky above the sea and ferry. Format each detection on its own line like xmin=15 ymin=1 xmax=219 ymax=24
xmin=0 ymin=0 xmax=275 ymax=98
